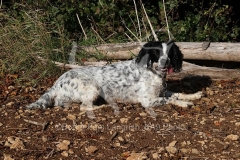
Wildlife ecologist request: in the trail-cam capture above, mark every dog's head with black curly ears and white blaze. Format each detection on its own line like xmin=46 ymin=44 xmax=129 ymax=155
xmin=136 ymin=41 xmax=183 ymax=74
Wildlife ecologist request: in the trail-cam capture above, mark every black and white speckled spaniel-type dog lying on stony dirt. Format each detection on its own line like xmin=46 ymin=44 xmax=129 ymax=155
xmin=27 ymin=41 xmax=202 ymax=118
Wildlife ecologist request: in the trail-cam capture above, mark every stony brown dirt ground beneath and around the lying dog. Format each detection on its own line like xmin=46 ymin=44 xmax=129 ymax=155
xmin=0 ymin=75 xmax=240 ymax=160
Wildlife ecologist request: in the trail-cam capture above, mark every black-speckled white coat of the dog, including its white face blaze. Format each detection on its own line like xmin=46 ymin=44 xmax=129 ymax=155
xmin=27 ymin=43 xmax=201 ymax=118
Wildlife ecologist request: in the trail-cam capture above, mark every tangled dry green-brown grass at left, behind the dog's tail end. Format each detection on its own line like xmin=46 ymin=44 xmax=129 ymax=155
xmin=0 ymin=12 xmax=67 ymax=82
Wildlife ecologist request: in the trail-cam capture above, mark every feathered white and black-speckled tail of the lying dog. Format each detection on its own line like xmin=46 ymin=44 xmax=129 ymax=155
xmin=26 ymin=90 xmax=53 ymax=109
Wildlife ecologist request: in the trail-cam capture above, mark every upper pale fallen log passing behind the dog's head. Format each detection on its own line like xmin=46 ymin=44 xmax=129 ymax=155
xmin=79 ymin=42 xmax=240 ymax=62
